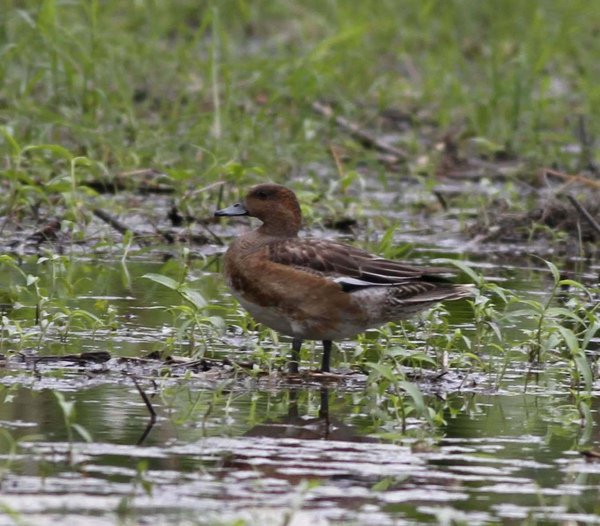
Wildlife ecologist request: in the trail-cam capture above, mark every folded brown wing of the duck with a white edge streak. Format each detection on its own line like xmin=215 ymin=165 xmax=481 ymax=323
xmin=268 ymin=238 xmax=449 ymax=289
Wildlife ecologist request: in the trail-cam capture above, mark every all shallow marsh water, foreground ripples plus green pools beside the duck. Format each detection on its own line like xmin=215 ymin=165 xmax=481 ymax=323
xmin=0 ymin=247 xmax=600 ymax=525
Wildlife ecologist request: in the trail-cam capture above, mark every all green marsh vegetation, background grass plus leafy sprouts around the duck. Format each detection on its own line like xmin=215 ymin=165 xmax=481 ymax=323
xmin=0 ymin=0 xmax=600 ymax=448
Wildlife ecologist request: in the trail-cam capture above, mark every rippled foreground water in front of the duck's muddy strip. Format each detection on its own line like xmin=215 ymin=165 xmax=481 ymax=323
xmin=1 ymin=385 xmax=600 ymax=524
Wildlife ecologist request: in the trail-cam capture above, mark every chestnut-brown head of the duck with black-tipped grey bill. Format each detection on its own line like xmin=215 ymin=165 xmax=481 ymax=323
xmin=215 ymin=183 xmax=302 ymax=236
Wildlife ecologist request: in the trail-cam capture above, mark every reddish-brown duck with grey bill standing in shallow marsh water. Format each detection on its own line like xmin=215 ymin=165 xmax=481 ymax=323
xmin=214 ymin=183 xmax=473 ymax=374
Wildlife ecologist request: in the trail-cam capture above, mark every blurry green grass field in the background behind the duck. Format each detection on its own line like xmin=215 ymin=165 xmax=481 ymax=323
xmin=0 ymin=0 xmax=600 ymax=212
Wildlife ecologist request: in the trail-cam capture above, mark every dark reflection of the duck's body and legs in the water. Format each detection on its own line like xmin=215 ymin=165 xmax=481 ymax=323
xmin=244 ymin=387 xmax=378 ymax=442
